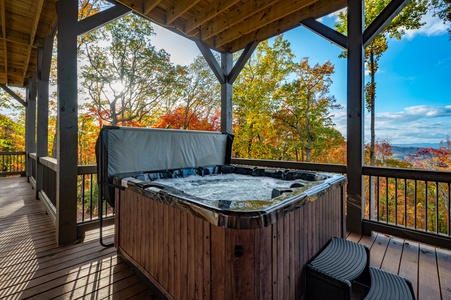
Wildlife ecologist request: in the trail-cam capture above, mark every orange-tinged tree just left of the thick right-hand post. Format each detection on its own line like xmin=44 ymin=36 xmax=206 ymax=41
xmin=275 ymin=58 xmax=341 ymax=162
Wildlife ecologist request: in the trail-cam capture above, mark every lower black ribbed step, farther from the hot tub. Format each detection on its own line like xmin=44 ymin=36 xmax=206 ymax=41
xmin=365 ymin=267 xmax=415 ymax=300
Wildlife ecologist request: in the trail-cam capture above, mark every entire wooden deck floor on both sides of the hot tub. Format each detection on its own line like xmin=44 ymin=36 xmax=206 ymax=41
xmin=0 ymin=178 xmax=451 ymax=300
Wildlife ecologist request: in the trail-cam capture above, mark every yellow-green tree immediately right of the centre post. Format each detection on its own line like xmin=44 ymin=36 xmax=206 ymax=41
xmin=233 ymin=35 xmax=294 ymax=158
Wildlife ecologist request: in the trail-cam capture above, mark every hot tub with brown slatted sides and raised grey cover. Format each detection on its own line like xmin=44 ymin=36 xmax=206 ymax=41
xmin=99 ymin=127 xmax=345 ymax=299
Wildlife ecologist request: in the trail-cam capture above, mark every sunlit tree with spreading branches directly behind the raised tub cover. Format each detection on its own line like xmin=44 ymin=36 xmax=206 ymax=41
xmin=82 ymin=15 xmax=175 ymax=125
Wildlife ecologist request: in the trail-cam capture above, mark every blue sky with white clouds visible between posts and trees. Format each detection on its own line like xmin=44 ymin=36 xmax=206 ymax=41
xmin=152 ymin=9 xmax=451 ymax=144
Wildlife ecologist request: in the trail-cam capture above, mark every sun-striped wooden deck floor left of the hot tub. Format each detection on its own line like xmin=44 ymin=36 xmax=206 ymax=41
xmin=0 ymin=178 xmax=162 ymax=299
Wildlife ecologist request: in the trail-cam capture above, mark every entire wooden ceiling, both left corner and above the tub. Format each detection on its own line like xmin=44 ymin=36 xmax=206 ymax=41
xmin=0 ymin=0 xmax=347 ymax=87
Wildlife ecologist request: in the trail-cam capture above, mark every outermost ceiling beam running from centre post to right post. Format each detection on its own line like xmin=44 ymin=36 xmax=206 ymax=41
xmin=224 ymin=0 xmax=346 ymax=52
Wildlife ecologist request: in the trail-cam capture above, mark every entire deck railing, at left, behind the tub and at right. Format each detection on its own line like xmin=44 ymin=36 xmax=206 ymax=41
xmin=3 ymin=152 xmax=451 ymax=248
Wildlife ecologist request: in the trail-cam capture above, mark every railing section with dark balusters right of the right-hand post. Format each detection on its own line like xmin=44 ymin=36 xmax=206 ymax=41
xmin=362 ymin=167 xmax=451 ymax=248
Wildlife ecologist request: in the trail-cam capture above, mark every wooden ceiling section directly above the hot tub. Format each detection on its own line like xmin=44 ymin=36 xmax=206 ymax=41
xmin=117 ymin=0 xmax=347 ymax=52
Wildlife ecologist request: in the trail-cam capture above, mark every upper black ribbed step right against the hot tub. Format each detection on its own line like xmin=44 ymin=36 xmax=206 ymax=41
xmin=306 ymin=237 xmax=369 ymax=299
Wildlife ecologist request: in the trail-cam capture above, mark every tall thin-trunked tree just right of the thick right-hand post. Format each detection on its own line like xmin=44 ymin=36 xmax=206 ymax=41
xmin=335 ymin=0 xmax=427 ymax=166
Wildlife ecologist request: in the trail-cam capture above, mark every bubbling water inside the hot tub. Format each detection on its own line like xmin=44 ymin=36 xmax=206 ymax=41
xmin=155 ymin=173 xmax=306 ymax=201
